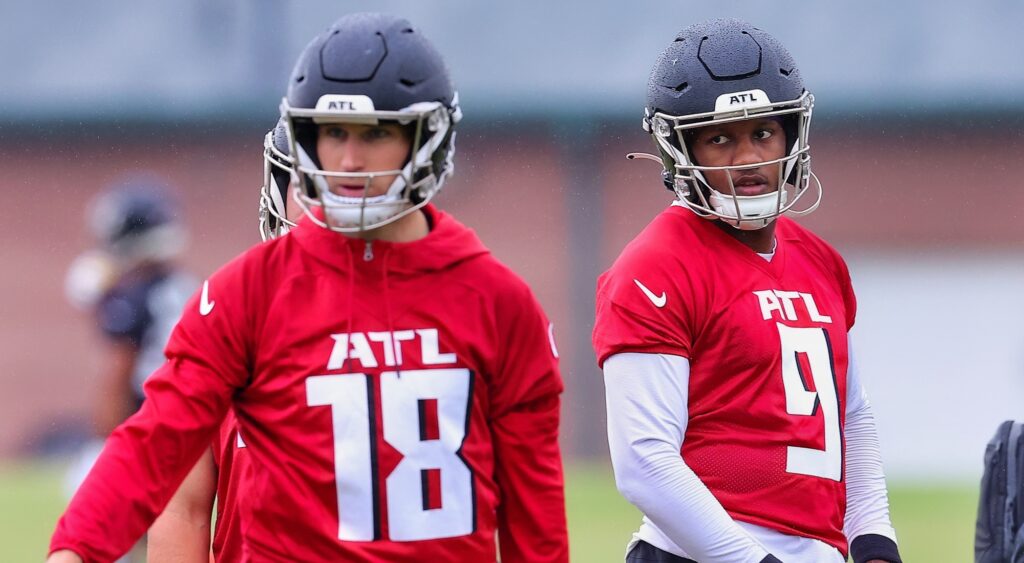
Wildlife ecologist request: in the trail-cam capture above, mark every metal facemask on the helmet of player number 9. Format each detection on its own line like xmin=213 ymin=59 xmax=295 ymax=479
xmin=643 ymin=91 xmax=821 ymax=230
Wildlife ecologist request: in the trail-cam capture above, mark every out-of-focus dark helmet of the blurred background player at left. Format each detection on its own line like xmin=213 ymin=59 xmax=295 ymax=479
xmin=89 ymin=174 xmax=185 ymax=264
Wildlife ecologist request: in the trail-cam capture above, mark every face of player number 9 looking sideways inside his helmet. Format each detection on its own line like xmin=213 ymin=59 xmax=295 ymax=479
xmin=690 ymin=119 xmax=785 ymax=196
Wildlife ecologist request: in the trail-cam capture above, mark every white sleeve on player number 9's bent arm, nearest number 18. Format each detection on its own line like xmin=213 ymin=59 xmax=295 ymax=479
xmin=604 ymin=353 xmax=768 ymax=563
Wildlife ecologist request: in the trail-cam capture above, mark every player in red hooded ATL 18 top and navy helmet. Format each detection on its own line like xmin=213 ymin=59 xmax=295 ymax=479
xmin=51 ymin=13 xmax=568 ymax=563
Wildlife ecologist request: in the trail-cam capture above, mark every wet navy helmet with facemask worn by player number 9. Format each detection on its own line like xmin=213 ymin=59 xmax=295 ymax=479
xmin=643 ymin=19 xmax=821 ymax=228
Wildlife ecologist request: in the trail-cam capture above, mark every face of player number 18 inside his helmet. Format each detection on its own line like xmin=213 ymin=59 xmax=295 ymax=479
xmin=316 ymin=123 xmax=412 ymax=198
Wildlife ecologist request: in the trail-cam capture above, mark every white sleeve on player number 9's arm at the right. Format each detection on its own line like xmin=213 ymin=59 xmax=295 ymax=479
xmin=843 ymin=342 xmax=896 ymax=542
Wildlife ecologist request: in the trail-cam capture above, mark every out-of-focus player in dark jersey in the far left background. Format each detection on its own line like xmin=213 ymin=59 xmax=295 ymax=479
xmin=66 ymin=173 xmax=197 ymax=560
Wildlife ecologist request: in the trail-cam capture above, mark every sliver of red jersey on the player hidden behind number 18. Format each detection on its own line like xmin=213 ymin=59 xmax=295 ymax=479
xmin=211 ymin=414 xmax=249 ymax=562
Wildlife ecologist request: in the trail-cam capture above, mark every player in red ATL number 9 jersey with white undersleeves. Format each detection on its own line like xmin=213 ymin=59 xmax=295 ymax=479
xmin=594 ymin=19 xmax=900 ymax=563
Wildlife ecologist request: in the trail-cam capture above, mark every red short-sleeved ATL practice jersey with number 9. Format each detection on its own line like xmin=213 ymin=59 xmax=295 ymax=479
xmin=594 ymin=206 xmax=856 ymax=555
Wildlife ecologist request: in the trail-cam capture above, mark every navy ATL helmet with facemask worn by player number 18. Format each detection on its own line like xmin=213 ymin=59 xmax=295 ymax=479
xmin=281 ymin=13 xmax=462 ymax=232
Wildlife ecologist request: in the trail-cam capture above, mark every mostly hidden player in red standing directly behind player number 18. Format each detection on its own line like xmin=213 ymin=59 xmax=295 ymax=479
xmin=146 ymin=120 xmax=302 ymax=563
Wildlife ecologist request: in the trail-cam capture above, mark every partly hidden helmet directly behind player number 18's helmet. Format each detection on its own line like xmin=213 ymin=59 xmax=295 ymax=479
xmin=259 ymin=118 xmax=295 ymax=241
